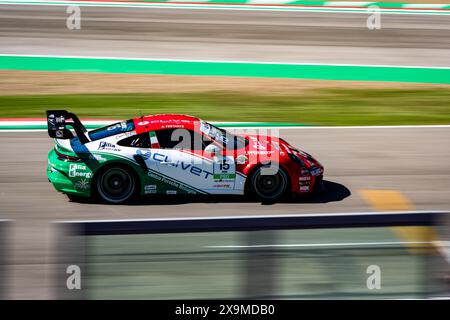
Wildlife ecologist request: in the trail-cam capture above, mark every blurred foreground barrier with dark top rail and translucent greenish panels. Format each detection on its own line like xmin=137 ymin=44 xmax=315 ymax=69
xmin=55 ymin=212 xmax=449 ymax=299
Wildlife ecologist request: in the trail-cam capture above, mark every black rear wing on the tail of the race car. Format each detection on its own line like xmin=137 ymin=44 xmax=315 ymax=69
xmin=47 ymin=110 xmax=89 ymax=143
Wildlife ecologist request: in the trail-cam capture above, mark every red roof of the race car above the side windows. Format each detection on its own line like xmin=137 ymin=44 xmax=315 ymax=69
xmin=133 ymin=114 xmax=201 ymax=133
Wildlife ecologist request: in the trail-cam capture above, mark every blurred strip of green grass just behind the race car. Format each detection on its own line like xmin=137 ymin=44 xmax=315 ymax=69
xmin=0 ymin=88 xmax=450 ymax=125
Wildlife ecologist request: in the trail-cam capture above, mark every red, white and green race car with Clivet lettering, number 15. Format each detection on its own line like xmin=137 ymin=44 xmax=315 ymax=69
xmin=47 ymin=110 xmax=324 ymax=204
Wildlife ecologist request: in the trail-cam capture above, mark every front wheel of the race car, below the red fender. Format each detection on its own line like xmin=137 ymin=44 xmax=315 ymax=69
xmin=250 ymin=167 xmax=289 ymax=203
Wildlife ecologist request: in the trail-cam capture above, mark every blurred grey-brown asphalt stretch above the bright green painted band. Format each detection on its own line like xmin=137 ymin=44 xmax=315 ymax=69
xmin=0 ymin=5 xmax=450 ymax=67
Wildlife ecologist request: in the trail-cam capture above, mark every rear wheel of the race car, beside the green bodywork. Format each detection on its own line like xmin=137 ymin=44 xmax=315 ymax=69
xmin=95 ymin=165 xmax=138 ymax=204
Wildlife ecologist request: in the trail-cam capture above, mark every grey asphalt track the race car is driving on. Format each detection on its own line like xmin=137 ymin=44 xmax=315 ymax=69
xmin=0 ymin=127 xmax=450 ymax=298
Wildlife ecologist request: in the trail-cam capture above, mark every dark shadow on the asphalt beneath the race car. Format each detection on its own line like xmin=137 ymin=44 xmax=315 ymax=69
xmin=93 ymin=180 xmax=351 ymax=206
